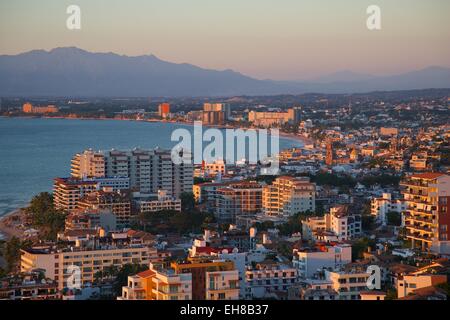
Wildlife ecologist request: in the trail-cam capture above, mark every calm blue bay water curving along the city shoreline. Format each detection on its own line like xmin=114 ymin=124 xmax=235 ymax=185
xmin=0 ymin=117 xmax=301 ymax=216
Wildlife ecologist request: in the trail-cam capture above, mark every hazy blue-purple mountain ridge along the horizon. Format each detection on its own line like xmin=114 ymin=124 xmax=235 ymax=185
xmin=0 ymin=47 xmax=450 ymax=97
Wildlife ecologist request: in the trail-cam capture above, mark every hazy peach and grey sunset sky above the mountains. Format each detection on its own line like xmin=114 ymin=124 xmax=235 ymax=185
xmin=0 ymin=0 xmax=450 ymax=80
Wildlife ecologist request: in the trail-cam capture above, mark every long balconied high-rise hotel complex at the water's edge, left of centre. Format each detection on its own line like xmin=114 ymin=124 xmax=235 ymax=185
xmin=53 ymin=148 xmax=193 ymax=212
